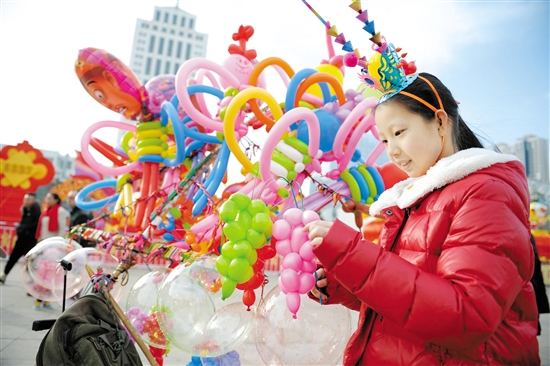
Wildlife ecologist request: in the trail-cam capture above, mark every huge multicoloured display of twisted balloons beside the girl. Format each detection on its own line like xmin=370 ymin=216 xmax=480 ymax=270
xmin=55 ymin=0 xmax=414 ymax=364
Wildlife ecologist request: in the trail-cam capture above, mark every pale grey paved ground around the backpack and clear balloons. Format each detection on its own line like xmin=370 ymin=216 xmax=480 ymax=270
xmin=0 ymin=264 xmax=550 ymax=366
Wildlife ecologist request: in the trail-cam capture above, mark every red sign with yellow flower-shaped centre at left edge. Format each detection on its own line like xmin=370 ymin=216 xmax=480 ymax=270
xmin=0 ymin=141 xmax=55 ymax=223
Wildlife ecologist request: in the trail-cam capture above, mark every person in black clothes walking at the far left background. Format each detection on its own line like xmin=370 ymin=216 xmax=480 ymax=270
xmin=0 ymin=193 xmax=40 ymax=284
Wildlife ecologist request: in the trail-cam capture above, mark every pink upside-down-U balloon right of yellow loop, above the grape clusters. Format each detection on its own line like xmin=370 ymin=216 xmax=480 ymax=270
xmin=260 ymin=107 xmax=321 ymax=192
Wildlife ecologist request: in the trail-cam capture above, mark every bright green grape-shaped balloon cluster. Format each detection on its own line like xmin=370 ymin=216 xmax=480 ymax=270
xmin=216 ymin=193 xmax=273 ymax=300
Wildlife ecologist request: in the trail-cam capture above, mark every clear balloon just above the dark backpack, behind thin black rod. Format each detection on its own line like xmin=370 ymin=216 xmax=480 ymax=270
xmin=50 ymin=248 xmax=122 ymax=302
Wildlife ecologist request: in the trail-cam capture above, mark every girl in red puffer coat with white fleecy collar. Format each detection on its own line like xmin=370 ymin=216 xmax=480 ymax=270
xmin=304 ymin=73 xmax=540 ymax=365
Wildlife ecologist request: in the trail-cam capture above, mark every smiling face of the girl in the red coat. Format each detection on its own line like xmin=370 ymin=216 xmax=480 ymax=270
xmin=375 ymin=103 xmax=446 ymax=178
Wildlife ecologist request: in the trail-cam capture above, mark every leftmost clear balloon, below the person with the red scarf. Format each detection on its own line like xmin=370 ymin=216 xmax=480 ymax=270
xmin=21 ymin=236 xmax=76 ymax=301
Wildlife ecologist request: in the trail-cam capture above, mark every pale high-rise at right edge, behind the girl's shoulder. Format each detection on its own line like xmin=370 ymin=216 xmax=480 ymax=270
xmin=497 ymin=135 xmax=549 ymax=183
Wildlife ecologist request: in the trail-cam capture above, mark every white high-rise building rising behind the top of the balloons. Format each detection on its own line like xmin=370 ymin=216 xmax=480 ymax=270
xmin=130 ymin=6 xmax=208 ymax=84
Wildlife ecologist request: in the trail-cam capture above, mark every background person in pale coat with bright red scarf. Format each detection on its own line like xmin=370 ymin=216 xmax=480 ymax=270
xmin=34 ymin=193 xmax=71 ymax=310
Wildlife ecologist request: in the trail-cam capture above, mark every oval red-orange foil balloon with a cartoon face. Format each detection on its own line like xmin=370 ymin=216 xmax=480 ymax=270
xmin=75 ymin=47 xmax=145 ymax=119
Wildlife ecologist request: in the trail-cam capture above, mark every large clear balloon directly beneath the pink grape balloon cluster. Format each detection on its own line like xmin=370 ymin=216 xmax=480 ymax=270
xmin=254 ymin=286 xmax=351 ymax=365
